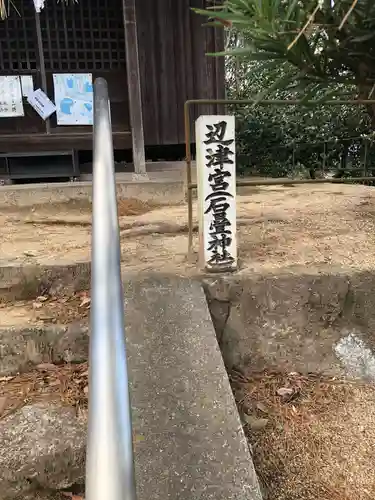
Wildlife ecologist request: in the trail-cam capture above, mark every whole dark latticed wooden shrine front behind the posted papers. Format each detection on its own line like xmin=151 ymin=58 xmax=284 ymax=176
xmin=0 ymin=0 xmax=131 ymax=151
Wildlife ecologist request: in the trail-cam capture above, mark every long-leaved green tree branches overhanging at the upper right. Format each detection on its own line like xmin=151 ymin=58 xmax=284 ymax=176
xmin=196 ymin=0 xmax=375 ymax=109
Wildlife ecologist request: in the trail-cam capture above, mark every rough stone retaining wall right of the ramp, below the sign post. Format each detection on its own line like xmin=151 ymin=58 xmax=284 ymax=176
xmin=204 ymin=271 xmax=375 ymax=380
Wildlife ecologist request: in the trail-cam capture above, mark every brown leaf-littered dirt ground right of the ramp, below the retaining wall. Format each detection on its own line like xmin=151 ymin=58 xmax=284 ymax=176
xmin=232 ymin=373 xmax=375 ymax=500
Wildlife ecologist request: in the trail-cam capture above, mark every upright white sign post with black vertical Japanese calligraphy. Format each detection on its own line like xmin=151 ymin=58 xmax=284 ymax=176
xmin=196 ymin=115 xmax=237 ymax=271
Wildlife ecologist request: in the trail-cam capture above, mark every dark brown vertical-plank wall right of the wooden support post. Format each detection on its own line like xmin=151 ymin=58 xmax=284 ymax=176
xmin=137 ymin=0 xmax=225 ymax=145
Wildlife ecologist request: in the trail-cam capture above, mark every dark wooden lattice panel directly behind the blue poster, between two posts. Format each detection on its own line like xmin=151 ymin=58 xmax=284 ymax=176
xmin=40 ymin=0 xmax=130 ymax=133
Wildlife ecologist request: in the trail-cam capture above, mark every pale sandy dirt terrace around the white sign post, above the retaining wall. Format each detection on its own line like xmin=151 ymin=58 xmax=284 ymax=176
xmin=0 ymin=184 xmax=375 ymax=274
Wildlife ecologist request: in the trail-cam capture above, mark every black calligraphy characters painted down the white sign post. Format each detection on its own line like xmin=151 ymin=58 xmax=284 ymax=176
xmin=204 ymin=121 xmax=235 ymax=268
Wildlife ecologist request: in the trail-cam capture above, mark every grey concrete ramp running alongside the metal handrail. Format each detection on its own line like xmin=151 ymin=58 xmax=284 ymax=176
xmin=125 ymin=276 xmax=261 ymax=500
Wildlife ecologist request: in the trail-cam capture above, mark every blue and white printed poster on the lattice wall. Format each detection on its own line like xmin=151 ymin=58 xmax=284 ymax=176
xmin=53 ymin=73 xmax=94 ymax=125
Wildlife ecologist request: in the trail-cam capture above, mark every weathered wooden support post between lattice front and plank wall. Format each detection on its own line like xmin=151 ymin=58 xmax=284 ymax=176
xmin=122 ymin=0 xmax=147 ymax=177
